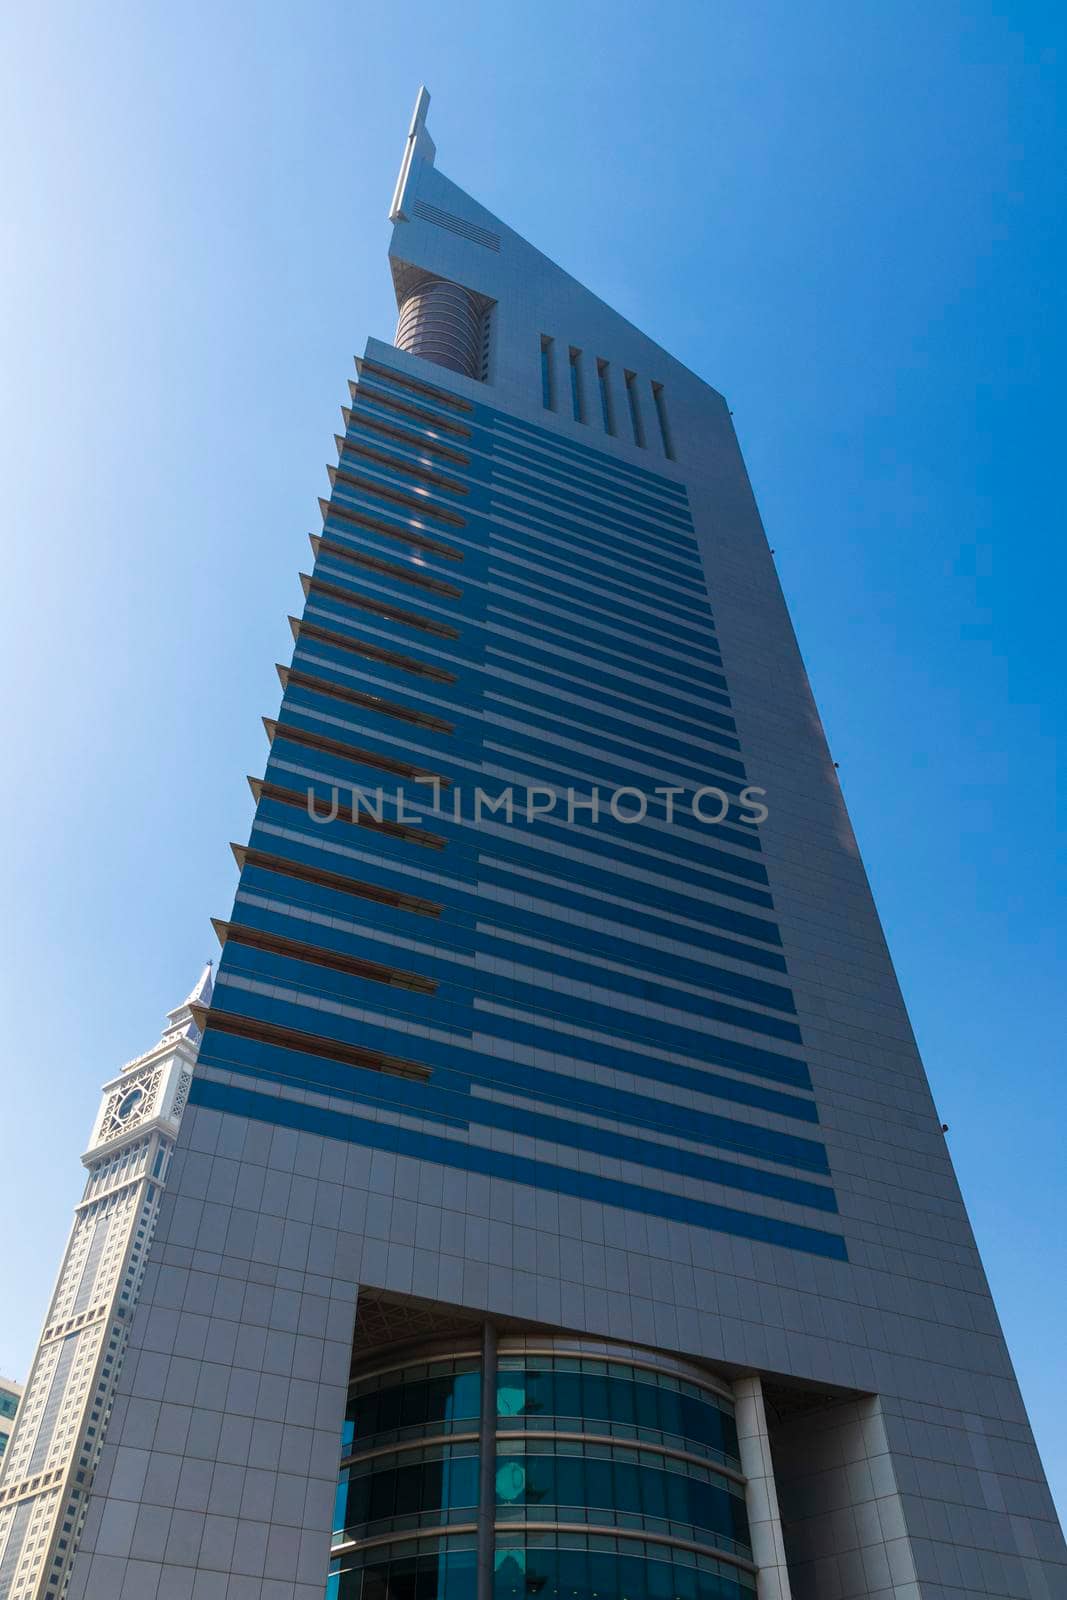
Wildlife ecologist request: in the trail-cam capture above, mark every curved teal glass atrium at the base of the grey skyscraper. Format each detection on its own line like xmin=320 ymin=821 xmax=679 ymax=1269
xmin=326 ymin=1334 xmax=755 ymax=1600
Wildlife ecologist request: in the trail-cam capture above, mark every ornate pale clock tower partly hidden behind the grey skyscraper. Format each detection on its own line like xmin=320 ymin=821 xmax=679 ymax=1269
xmin=0 ymin=962 xmax=211 ymax=1600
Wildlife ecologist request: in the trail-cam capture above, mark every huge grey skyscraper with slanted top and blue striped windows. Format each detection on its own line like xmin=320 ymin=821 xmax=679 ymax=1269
xmin=60 ymin=93 xmax=1067 ymax=1600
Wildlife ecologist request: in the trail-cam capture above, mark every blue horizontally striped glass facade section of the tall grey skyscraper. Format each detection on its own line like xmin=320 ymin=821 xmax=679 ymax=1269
xmin=194 ymin=362 xmax=846 ymax=1259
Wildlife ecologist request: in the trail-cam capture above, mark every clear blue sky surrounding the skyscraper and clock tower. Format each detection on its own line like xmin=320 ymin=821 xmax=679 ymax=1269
xmin=0 ymin=0 xmax=1067 ymax=1509
